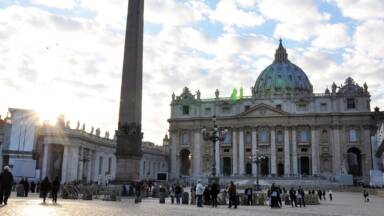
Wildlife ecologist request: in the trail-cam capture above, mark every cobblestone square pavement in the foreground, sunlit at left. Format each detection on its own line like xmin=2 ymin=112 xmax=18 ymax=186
xmin=0 ymin=193 xmax=384 ymax=216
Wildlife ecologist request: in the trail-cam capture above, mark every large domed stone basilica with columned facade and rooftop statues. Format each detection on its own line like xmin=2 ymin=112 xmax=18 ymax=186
xmin=168 ymin=41 xmax=376 ymax=180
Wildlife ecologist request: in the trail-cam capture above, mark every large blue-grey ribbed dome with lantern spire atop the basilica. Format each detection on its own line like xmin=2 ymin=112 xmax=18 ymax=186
xmin=252 ymin=40 xmax=313 ymax=95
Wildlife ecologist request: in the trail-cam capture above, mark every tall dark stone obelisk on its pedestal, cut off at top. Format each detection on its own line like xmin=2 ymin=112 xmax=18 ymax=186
xmin=116 ymin=0 xmax=144 ymax=183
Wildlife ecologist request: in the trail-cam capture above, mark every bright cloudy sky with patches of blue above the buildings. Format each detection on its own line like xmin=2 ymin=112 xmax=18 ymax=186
xmin=0 ymin=0 xmax=384 ymax=144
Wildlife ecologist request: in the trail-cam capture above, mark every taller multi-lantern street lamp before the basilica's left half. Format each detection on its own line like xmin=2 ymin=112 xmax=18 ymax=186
xmin=201 ymin=115 xmax=227 ymax=183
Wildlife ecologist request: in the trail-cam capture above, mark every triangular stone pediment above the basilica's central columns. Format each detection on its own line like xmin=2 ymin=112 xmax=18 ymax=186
xmin=239 ymin=104 xmax=289 ymax=117
